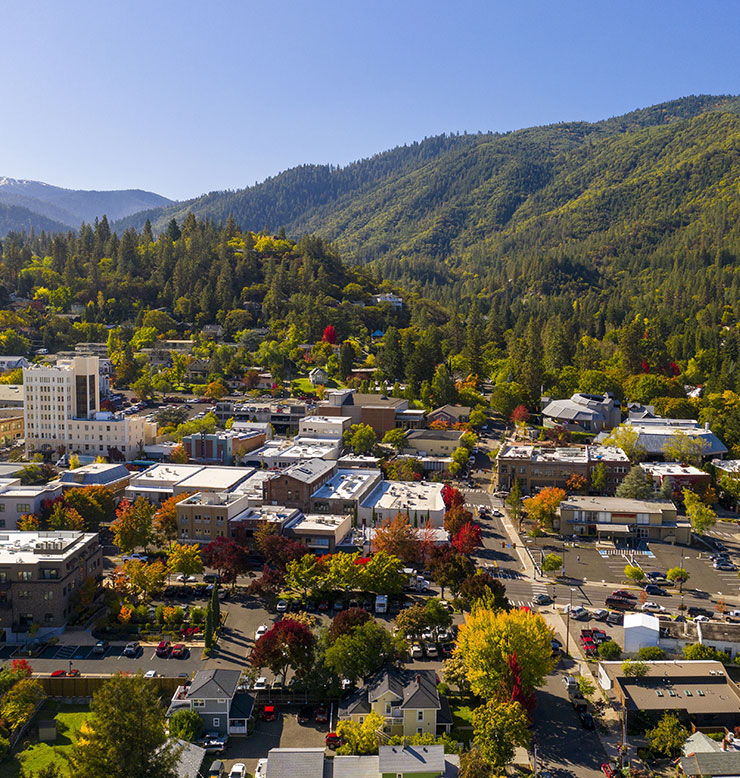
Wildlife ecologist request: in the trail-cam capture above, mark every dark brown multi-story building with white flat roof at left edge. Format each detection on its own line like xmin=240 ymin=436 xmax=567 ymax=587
xmin=0 ymin=531 xmax=103 ymax=641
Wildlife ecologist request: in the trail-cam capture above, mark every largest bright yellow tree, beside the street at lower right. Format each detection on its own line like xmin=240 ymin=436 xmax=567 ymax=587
xmin=457 ymin=608 xmax=552 ymax=699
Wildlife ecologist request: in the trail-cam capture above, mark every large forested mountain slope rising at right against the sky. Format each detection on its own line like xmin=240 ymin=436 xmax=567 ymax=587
xmin=115 ymin=95 xmax=740 ymax=296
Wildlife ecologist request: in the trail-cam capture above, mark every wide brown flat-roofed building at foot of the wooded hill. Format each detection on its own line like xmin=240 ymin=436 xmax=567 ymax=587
xmin=316 ymin=389 xmax=424 ymax=439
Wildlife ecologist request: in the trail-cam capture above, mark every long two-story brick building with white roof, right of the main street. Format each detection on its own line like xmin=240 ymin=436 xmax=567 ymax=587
xmin=496 ymin=443 xmax=630 ymax=494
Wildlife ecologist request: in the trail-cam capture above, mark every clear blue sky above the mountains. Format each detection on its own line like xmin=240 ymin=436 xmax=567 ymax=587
xmin=0 ymin=0 xmax=740 ymax=199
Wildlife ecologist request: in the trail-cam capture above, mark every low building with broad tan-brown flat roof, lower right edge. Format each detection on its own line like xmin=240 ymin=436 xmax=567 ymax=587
xmin=598 ymin=660 xmax=740 ymax=730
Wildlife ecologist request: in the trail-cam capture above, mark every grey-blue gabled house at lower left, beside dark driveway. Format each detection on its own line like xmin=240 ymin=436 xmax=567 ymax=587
xmin=167 ymin=669 xmax=254 ymax=735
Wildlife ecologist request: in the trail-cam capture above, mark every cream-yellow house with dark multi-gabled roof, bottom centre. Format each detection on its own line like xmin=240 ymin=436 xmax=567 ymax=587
xmin=338 ymin=666 xmax=452 ymax=735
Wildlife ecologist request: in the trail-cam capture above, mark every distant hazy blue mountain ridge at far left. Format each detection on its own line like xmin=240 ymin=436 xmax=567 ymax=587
xmin=0 ymin=177 xmax=172 ymax=234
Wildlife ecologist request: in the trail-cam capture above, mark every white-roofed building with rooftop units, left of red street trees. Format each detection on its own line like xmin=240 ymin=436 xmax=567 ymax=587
xmin=357 ymin=481 xmax=445 ymax=527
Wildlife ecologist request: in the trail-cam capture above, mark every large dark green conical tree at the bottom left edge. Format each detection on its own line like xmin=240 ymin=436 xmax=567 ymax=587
xmin=69 ymin=673 xmax=177 ymax=778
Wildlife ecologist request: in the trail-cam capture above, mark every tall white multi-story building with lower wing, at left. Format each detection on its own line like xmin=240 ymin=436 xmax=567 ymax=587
xmin=23 ymin=357 xmax=157 ymax=459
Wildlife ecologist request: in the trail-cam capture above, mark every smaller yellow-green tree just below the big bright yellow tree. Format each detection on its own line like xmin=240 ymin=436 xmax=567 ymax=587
xmin=473 ymin=700 xmax=530 ymax=772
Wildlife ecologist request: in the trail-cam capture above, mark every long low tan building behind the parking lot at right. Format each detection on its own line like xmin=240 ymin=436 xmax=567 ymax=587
xmin=554 ymin=495 xmax=691 ymax=544
